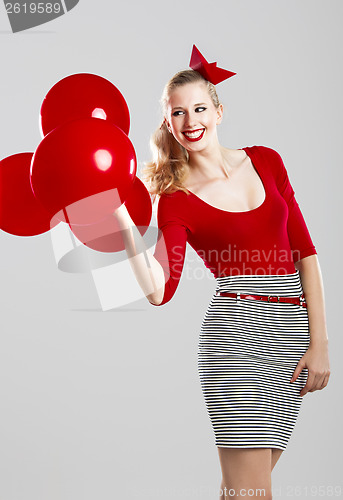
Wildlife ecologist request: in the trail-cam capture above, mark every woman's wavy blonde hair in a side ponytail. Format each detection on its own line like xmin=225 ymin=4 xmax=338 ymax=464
xmin=142 ymin=69 xmax=220 ymax=197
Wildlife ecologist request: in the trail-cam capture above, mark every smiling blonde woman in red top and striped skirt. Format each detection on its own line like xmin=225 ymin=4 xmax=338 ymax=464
xmin=116 ymin=47 xmax=330 ymax=499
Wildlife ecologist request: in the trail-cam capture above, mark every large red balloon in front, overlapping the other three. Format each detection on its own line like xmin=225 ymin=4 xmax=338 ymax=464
xmin=31 ymin=118 xmax=137 ymax=224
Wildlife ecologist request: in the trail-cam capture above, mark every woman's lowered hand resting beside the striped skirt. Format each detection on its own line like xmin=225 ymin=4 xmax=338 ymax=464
xmin=290 ymin=340 xmax=330 ymax=396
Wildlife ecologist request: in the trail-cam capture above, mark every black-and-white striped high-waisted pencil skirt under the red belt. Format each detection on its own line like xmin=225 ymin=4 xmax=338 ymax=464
xmin=198 ymin=270 xmax=310 ymax=450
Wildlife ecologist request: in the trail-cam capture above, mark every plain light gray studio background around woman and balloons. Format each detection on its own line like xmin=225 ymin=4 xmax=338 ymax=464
xmin=0 ymin=0 xmax=343 ymax=500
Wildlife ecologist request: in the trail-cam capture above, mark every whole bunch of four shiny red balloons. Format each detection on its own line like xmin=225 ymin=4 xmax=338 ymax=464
xmin=0 ymin=73 xmax=152 ymax=252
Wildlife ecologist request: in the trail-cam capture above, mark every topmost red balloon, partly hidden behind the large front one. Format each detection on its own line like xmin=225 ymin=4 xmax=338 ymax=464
xmin=40 ymin=73 xmax=130 ymax=136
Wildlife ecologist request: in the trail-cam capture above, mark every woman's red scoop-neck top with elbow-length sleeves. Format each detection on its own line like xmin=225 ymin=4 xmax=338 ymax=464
xmin=154 ymin=146 xmax=317 ymax=305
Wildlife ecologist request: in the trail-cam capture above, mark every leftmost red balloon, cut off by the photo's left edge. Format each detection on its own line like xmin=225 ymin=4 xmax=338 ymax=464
xmin=0 ymin=153 xmax=60 ymax=236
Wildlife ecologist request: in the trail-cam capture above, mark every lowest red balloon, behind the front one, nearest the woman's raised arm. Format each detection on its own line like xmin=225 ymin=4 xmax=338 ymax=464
xmin=70 ymin=177 xmax=152 ymax=252
